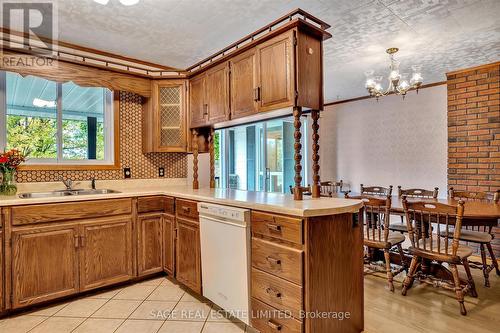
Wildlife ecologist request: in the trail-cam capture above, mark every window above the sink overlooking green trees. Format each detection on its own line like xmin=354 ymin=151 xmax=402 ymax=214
xmin=0 ymin=72 xmax=114 ymax=165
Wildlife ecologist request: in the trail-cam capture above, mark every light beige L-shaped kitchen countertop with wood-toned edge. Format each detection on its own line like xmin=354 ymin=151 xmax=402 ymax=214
xmin=0 ymin=180 xmax=362 ymax=217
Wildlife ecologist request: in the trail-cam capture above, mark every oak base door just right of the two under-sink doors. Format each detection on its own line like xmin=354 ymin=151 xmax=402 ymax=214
xmin=137 ymin=214 xmax=163 ymax=276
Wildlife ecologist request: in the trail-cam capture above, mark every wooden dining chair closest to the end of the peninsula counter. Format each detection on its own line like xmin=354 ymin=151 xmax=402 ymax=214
xmin=348 ymin=195 xmax=406 ymax=291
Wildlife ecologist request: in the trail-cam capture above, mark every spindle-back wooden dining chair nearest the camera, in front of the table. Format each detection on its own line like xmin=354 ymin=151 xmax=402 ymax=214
xmin=401 ymin=196 xmax=477 ymax=315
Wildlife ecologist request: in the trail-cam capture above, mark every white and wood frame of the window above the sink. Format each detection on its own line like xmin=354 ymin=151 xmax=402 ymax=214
xmin=0 ymin=70 xmax=120 ymax=170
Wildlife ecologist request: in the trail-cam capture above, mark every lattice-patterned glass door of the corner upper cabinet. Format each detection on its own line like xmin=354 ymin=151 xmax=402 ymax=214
xmin=155 ymin=83 xmax=187 ymax=152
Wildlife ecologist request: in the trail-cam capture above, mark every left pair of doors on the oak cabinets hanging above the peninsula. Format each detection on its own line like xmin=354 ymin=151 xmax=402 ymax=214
xmin=189 ymin=62 xmax=229 ymax=128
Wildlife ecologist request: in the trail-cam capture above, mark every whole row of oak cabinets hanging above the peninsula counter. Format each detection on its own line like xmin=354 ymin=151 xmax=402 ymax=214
xmin=189 ymin=27 xmax=323 ymax=128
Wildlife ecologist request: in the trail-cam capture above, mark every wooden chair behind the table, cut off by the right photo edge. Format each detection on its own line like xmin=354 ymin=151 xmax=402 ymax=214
xmin=441 ymin=187 xmax=500 ymax=287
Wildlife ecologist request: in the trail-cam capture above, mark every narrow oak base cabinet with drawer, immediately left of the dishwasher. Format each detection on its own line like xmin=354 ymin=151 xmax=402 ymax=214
xmin=175 ymin=199 xmax=201 ymax=294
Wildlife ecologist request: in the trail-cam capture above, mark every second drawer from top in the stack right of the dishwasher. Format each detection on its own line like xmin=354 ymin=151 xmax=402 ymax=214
xmin=252 ymin=238 xmax=303 ymax=285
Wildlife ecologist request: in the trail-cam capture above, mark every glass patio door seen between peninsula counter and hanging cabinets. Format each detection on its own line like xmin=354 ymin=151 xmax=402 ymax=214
xmin=215 ymin=117 xmax=309 ymax=193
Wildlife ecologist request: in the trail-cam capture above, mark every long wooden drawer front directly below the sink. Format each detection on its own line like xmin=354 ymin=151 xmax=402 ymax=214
xmin=12 ymin=198 xmax=132 ymax=225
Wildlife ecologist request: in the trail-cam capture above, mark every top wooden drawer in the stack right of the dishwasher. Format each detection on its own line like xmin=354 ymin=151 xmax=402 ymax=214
xmin=252 ymin=211 xmax=302 ymax=244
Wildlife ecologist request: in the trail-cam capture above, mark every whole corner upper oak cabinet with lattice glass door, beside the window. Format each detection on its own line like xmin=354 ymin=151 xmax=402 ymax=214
xmin=143 ymin=80 xmax=189 ymax=153
